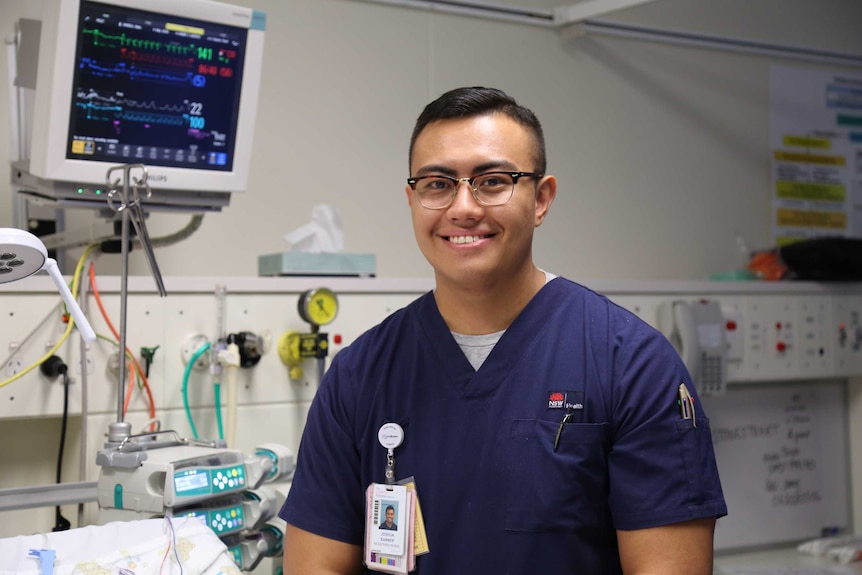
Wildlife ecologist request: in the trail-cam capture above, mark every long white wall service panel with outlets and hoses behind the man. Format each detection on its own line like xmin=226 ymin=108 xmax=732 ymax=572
xmin=0 ymin=276 xmax=862 ymax=556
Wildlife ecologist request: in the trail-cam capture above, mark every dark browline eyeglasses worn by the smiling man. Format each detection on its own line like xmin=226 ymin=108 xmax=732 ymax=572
xmin=407 ymin=172 xmax=543 ymax=210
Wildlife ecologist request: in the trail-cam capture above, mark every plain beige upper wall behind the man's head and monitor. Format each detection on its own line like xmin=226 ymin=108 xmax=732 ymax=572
xmin=0 ymin=0 xmax=862 ymax=279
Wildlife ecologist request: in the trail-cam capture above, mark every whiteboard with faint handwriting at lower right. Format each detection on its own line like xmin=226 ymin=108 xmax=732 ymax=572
xmin=702 ymin=381 xmax=850 ymax=549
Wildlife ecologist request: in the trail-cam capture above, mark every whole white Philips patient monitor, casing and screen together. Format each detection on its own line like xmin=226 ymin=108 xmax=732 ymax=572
xmin=22 ymin=0 xmax=266 ymax=208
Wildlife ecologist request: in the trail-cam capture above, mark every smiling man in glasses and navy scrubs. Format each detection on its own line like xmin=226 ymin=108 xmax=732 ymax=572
xmin=281 ymin=88 xmax=726 ymax=575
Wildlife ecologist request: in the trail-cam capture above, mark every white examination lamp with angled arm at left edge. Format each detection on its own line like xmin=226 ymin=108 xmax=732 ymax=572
xmin=0 ymin=228 xmax=96 ymax=343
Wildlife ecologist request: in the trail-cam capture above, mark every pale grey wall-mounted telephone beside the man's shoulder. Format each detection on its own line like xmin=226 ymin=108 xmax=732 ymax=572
xmin=658 ymin=300 xmax=728 ymax=395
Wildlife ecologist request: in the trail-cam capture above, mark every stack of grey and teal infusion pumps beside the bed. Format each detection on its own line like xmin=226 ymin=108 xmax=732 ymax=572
xmin=96 ymin=431 xmax=293 ymax=571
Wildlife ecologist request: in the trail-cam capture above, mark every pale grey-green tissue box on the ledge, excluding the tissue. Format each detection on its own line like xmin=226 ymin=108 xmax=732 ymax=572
xmin=257 ymin=252 xmax=377 ymax=277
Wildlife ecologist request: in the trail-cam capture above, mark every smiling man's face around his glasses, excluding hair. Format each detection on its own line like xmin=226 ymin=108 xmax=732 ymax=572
xmin=406 ymin=114 xmax=555 ymax=288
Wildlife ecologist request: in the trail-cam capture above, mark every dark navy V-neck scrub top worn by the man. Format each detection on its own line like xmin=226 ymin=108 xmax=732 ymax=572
xmin=280 ymin=278 xmax=727 ymax=575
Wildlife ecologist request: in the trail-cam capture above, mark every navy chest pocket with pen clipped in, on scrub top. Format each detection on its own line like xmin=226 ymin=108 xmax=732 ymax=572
xmin=505 ymin=419 xmax=609 ymax=532
